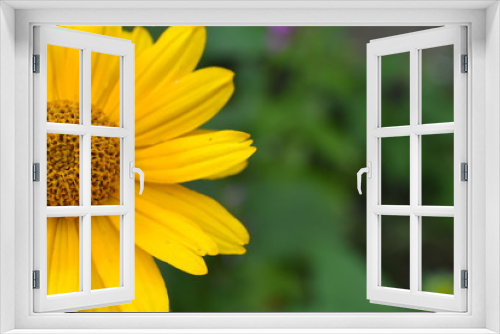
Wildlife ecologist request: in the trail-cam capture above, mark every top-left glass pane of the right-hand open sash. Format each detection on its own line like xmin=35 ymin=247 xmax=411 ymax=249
xmin=380 ymin=52 xmax=410 ymax=126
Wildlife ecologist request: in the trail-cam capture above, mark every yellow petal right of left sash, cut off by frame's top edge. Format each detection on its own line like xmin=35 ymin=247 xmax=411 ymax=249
xmin=135 ymin=27 xmax=206 ymax=100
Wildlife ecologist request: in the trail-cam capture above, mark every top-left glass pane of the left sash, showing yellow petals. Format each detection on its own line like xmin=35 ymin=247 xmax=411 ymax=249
xmin=47 ymin=45 xmax=80 ymax=124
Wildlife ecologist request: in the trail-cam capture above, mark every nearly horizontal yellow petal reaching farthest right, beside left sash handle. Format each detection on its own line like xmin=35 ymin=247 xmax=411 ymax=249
xmin=136 ymin=130 xmax=256 ymax=183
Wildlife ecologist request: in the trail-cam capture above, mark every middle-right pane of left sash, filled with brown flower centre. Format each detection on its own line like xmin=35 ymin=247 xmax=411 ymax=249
xmin=91 ymin=137 xmax=120 ymax=205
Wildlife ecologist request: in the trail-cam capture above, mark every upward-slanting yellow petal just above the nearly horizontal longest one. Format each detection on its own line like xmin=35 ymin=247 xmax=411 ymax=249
xmin=136 ymin=67 xmax=234 ymax=146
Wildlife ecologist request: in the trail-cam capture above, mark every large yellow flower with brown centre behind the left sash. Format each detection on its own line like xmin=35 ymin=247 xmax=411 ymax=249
xmin=47 ymin=27 xmax=256 ymax=312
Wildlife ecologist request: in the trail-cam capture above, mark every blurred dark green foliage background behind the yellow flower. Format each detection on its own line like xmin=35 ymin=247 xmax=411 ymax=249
xmin=127 ymin=27 xmax=453 ymax=312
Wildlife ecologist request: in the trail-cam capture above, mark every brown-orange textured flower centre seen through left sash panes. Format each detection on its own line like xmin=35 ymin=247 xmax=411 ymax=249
xmin=47 ymin=101 xmax=120 ymax=206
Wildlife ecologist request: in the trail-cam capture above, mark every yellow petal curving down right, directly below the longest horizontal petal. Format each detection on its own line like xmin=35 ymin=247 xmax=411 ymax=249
xmin=147 ymin=183 xmax=250 ymax=254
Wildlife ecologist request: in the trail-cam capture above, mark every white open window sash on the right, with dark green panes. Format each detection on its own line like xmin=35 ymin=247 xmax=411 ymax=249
xmin=367 ymin=26 xmax=468 ymax=312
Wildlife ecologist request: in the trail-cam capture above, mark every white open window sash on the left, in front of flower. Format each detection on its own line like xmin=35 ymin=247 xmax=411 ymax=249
xmin=33 ymin=26 xmax=135 ymax=312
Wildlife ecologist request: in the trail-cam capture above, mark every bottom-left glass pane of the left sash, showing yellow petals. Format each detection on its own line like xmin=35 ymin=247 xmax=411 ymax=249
xmin=47 ymin=217 xmax=80 ymax=295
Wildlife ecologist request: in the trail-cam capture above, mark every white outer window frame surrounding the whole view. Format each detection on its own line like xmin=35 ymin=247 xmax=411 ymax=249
xmin=0 ymin=0 xmax=500 ymax=333
